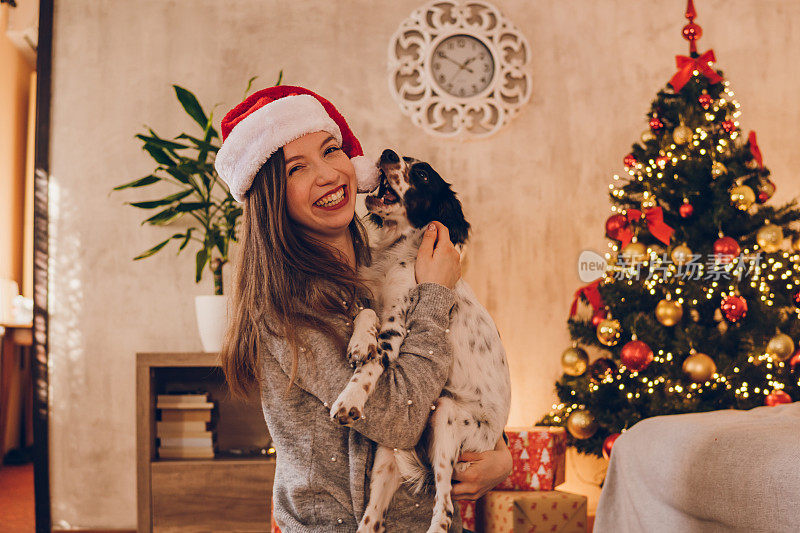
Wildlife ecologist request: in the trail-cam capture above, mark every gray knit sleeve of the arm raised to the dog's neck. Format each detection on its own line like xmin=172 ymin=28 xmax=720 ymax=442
xmin=260 ymin=282 xmax=455 ymax=449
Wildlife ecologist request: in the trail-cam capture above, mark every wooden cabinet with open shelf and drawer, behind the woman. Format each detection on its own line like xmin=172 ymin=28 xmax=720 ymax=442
xmin=136 ymin=352 xmax=275 ymax=532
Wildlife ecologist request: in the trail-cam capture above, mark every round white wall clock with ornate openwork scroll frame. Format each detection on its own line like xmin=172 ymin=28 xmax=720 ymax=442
xmin=389 ymin=0 xmax=531 ymax=137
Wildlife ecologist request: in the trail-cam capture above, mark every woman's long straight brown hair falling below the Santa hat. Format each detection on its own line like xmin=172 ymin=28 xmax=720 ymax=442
xmin=220 ymin=145 xmax=371 ymax=400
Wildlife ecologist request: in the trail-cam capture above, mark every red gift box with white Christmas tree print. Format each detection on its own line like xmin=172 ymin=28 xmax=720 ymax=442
xmin=496 ymin=426 xmax=567 ymax=490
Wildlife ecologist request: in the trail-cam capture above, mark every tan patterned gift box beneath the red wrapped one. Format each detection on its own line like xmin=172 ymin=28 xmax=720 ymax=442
xmin=474 ymin=490 xmax=587 ymax=533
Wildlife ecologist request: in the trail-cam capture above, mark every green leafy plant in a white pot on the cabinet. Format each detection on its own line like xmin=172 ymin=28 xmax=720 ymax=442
xmin=112 ymin=75 xmax=272 ymax=352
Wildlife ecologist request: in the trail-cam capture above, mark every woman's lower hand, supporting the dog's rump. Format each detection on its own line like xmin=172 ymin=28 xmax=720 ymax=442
xmin=452 ymin=437 xmax=513 ymax=500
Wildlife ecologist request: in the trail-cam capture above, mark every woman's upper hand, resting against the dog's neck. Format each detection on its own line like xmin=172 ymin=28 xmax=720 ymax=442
xmin=414 ymin=221 xmax=461 ymax=289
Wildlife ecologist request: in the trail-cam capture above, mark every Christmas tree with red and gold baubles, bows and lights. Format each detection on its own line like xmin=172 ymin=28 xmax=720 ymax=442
xmin=540 ymin=0 xmax=800 ymax=456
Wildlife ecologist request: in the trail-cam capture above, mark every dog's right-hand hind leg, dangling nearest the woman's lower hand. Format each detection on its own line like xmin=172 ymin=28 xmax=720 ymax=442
xmin=428 ymin=397 xmax=464 ymax=533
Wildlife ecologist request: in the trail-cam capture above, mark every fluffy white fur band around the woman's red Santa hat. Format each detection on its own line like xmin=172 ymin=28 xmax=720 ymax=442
xmin=214 ymin=94 xmax=342 ymax=202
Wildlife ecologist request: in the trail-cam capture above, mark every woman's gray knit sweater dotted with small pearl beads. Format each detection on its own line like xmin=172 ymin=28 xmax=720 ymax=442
xmin=261 ymin=283 xmax=461 ymax=533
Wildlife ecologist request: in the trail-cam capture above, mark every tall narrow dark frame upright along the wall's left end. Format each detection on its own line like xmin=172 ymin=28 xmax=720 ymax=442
xmin=31 ymin=0 xmax=53 ymax=533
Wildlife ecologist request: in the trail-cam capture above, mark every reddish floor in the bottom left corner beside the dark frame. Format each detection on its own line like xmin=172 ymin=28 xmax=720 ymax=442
xmin=0 ymin=463 xmax=36 ymax=533
